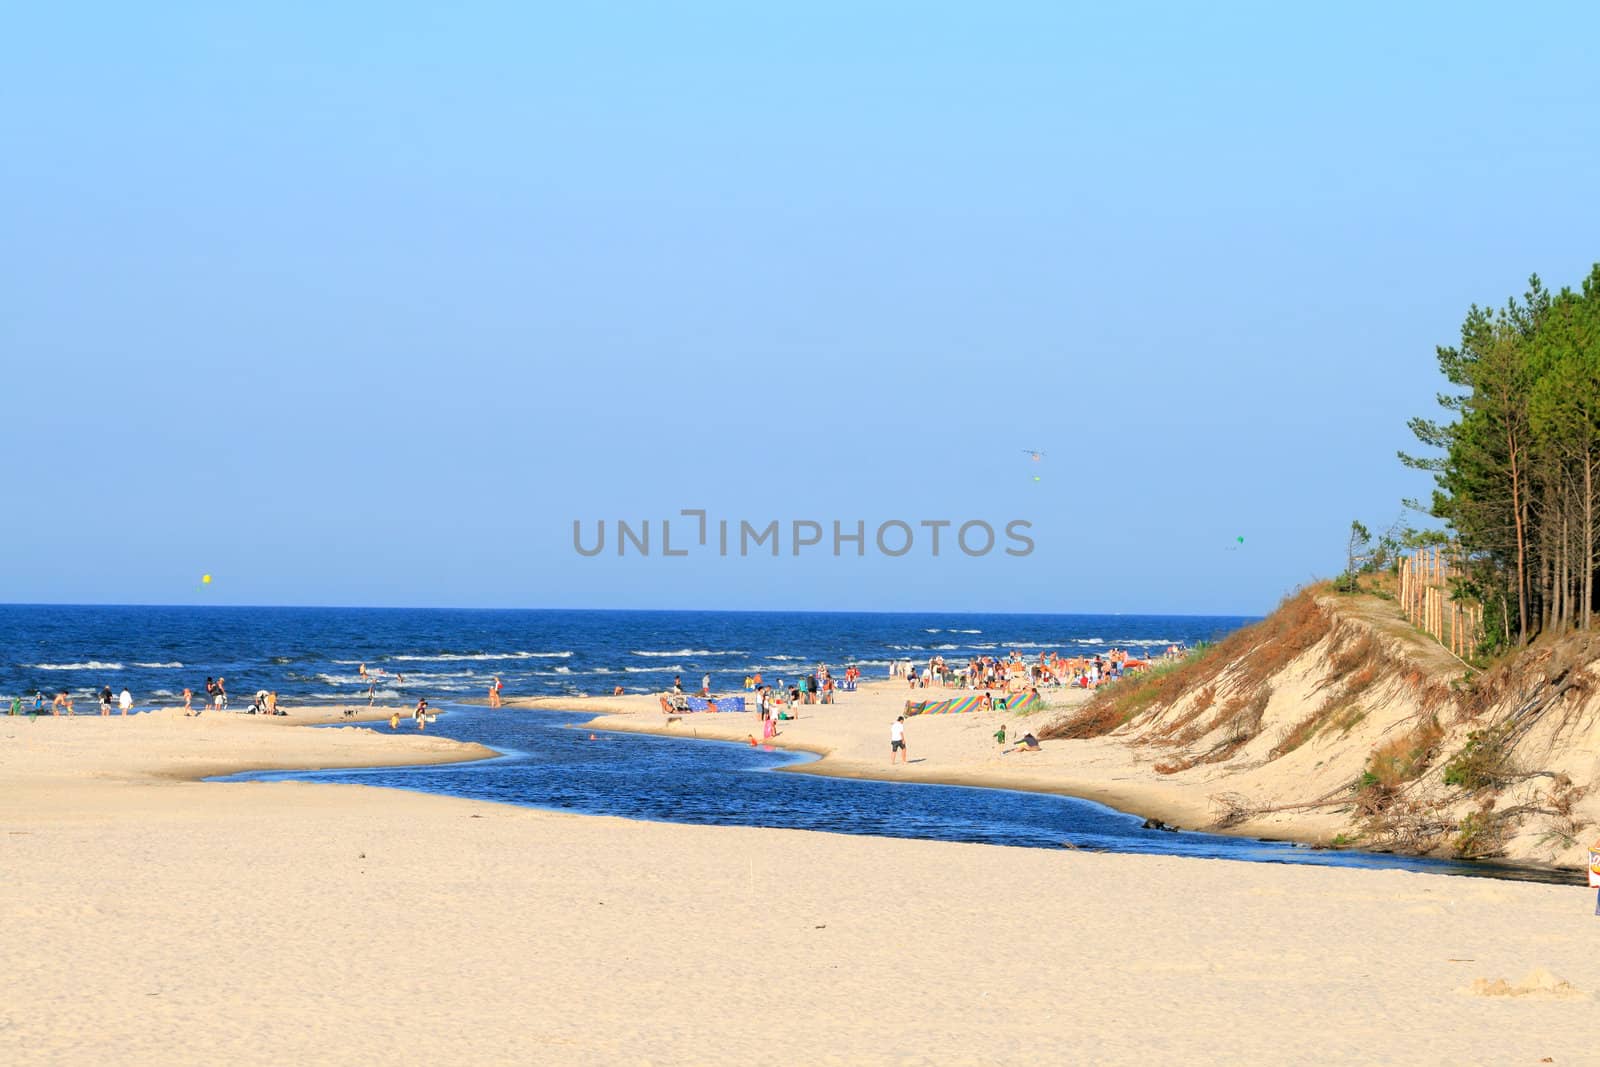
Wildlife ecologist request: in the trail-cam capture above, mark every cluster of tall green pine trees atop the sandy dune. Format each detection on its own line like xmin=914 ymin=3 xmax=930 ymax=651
xmin=1400 ymin=264 xmax=1600 ymax=657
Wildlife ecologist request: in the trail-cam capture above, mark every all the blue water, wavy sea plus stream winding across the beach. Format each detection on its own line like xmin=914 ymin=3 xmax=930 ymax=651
xmin=0 ymin=605 xmax=1573 ymax=881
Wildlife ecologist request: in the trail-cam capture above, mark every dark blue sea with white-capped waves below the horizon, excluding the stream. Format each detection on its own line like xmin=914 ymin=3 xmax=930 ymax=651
xmin=0 ymin=605 xmax=1253 ymax=707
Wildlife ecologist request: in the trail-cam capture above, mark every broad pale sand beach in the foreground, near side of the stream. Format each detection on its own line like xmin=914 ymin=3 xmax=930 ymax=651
xmin=0 ymin=702 xmax=1600 ymax=1064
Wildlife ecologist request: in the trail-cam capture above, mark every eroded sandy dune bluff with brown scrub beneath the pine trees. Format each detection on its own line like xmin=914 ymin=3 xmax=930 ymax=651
xmin=1046 ymin=589 xmax=1600 ymax=867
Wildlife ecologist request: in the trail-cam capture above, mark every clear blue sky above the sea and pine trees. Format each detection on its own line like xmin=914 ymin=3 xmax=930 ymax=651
xmin=0 ymin=3 xmax=1600 ymax=613
